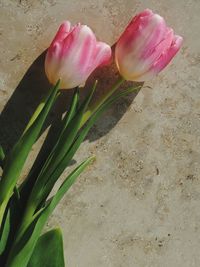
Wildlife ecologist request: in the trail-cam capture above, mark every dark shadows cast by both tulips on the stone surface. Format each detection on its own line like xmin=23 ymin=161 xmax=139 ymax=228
xmin=0 ymin=51 xmax=142 ymax=157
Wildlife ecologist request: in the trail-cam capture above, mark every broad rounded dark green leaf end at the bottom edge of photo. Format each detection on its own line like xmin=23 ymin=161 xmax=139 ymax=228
xmin=27 ymin=229 xmax=65 ymax=267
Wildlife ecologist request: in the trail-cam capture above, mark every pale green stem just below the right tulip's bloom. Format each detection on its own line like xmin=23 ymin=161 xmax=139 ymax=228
xmin=80 ymin=77 xmax=125 ymax=128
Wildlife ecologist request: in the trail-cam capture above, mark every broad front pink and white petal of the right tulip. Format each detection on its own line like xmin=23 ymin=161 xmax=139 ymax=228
xmin=116 ymin=13 xmax=167 ymax=77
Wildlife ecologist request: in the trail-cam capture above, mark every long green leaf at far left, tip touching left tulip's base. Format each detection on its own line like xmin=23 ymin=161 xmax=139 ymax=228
xmin=0 ymin=81 xmax=59 ymax=224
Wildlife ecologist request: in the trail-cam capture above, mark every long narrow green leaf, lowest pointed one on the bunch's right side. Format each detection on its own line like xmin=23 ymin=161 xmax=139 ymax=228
xmin=5 ymin=157 xmax=94 ymax=267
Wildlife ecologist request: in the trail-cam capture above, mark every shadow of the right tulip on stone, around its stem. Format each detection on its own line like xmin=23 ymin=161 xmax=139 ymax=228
xmin=85 ymin=56 xmax=143 ymax=142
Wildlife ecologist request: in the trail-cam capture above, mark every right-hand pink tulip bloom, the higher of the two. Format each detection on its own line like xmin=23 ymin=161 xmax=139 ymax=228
xmin=115 ymin=9 xmax=183 ymax=81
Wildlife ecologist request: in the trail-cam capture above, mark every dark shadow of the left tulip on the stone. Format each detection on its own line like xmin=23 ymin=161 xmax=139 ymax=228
xmin=0 ymin=51 xmax=72 ymax=156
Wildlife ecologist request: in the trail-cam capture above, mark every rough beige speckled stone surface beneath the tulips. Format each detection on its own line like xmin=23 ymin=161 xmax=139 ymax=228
xmin=0 ymin=0 xmax=200 ymax=267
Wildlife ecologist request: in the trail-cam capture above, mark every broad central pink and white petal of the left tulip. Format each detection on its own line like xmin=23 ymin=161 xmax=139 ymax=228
xmin=56 ymin=25 xmax=99 ymax=88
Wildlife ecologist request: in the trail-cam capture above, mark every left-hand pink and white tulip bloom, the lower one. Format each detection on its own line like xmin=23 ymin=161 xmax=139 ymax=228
xmin=45 ymin=21 xmax=111 ymax=89
